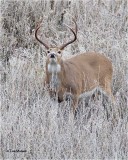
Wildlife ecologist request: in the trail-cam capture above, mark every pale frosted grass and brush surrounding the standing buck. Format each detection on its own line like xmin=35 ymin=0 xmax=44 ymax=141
xmin=0 ymin=0 xmax=128 ymax=160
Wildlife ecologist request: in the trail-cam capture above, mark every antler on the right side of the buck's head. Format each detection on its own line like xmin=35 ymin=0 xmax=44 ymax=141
xmin=59 ymin=18 xmax=77 ymax=50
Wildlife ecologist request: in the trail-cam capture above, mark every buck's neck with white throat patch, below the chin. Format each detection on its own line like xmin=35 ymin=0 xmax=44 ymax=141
xmin=47 ymin=60 xmax=63 ymax=91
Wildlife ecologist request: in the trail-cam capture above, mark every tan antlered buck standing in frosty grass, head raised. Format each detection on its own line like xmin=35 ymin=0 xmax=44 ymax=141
xmin=35 ymin=21 xmax=113 ymax=113
